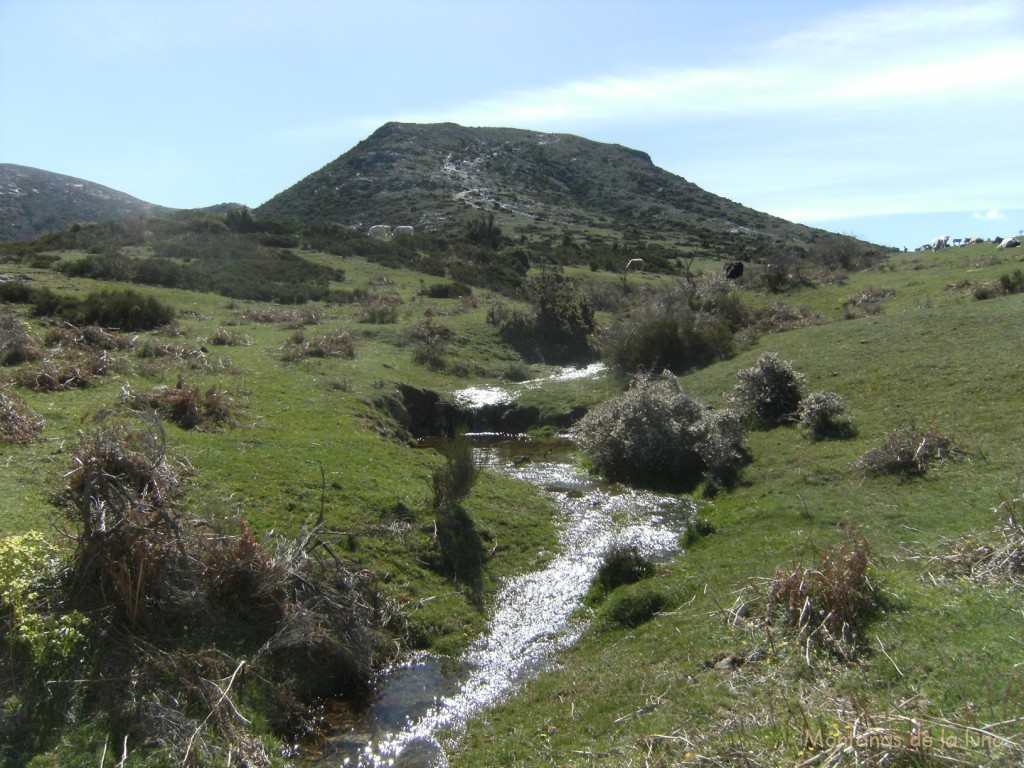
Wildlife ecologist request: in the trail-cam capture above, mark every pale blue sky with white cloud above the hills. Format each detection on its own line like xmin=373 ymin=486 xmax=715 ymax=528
xmin=0 ymin=0 xmax=1024 ymax=248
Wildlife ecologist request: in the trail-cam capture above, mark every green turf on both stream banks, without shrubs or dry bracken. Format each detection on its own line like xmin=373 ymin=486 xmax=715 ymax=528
xmin=0 ymin=241 xmax=1024 ymax=765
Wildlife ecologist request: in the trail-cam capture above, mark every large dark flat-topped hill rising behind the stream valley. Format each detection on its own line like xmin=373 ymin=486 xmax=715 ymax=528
xmin=255 ymin=123 xmax=847 ymax=248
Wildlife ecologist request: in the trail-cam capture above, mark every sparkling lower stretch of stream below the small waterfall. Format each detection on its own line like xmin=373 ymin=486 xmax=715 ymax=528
xmin=303 ymin=372 xmax=696 ymax=768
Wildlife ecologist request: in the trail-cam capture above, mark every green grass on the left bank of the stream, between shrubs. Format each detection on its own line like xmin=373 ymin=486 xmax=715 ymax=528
xmin=0 ymin=250 xmax=555 ymax=663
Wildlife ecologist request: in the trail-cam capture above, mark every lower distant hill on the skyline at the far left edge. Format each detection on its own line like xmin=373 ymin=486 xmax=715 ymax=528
xmin=0 ymin=163 xmax=173 ymax=241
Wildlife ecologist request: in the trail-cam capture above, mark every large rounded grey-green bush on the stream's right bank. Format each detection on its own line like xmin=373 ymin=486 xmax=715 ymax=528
xmin=577 ymin=372 xmax=745 ymax=489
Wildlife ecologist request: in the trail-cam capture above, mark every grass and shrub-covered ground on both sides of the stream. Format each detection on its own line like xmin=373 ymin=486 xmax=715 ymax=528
xmin=0 ymin=196 xmax=1024 ymax=766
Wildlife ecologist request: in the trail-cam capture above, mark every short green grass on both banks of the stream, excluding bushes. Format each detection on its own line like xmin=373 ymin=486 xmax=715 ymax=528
xmin=0 ymin=233 xmax=1024 ymax=766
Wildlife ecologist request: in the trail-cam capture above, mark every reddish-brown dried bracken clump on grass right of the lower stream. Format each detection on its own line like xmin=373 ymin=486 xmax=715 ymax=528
xmin=763 ymin=532 xmax=882 ymax=660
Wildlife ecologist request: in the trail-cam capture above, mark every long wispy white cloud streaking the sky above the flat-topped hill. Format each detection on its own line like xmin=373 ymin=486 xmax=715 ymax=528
xmin=411 ymin=2 xmax=1024 ymax=127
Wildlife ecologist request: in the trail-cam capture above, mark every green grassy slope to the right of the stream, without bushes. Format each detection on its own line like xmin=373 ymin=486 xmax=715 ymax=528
xmin=453 ymin=250 xmax=1024 ymax=766
